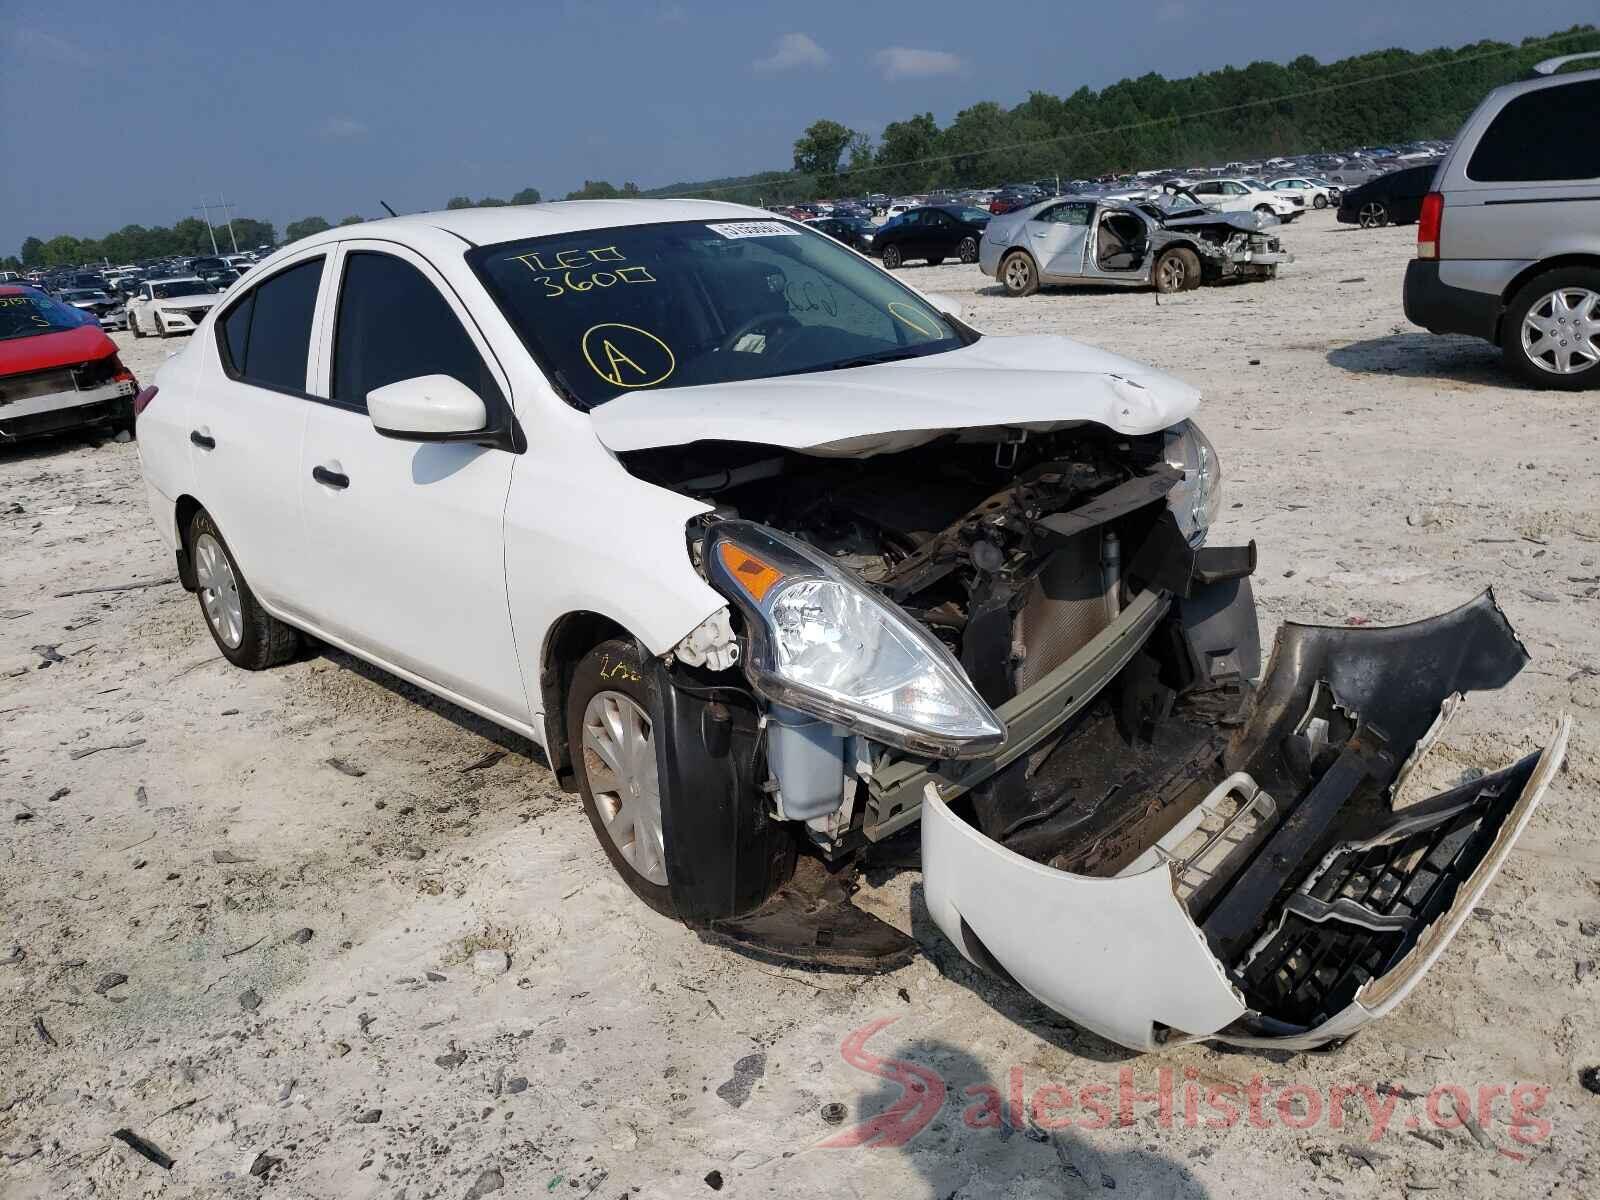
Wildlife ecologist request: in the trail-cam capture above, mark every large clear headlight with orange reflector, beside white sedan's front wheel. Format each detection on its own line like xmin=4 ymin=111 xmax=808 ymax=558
xmin=706 ymin=522 xmax=1005 ymax=758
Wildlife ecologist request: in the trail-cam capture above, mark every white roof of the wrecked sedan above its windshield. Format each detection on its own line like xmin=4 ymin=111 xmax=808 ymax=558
xmin=293 ymin=200 xmax=773 ymax=250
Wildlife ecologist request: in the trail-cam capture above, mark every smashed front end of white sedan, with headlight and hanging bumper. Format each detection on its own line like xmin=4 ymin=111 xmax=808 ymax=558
xmin=608 ymin=376 xmax=1565 ymax=1048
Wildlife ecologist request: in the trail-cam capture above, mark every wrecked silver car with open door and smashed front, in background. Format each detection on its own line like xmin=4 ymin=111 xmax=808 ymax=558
xmin=978 ymin=190 xmax=1294 ymax=296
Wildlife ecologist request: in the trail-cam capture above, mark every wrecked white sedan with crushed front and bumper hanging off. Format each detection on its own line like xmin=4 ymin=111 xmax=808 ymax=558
xmin=136 ymin=200 xmax=1562 ymax=1048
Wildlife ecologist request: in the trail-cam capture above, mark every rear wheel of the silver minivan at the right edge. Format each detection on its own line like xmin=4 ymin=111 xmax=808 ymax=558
xmin=1501 ymin=267 xmax=1600 ymax=392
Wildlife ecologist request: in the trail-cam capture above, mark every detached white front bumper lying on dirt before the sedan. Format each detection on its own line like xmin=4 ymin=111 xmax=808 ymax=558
xmin=920 ymin=592 xmax=1568 ymax=1050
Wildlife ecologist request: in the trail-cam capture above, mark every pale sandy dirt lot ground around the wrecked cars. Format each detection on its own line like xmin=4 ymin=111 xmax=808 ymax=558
xmin=9 ymin=213 xmax=1600 ymax=1200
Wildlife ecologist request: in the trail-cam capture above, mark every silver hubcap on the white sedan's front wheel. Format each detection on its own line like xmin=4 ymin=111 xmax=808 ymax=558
xmin=584 ymin=691 xmax=667 ymax=886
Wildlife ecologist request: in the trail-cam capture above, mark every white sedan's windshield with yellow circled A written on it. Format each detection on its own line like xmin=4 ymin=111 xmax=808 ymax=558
xmin=467 ymin=221 xmax=965 ymax=410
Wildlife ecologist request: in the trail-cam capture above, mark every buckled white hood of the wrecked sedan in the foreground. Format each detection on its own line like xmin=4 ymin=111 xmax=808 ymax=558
xmin=589 ymin=334 xmax=1200 ymax=458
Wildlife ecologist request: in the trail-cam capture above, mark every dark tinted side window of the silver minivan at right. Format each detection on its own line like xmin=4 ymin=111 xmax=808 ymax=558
xmin=1467 ymin=80 xmax=1600 ymax=184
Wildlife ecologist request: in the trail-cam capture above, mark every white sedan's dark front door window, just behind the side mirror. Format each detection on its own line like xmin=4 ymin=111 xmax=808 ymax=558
xmin=333 ymin=251 xmax=502 ymax=413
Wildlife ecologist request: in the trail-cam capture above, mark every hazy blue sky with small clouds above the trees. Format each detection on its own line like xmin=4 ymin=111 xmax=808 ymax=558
xmin=0 ymin=0 xmax=1561 ymax=253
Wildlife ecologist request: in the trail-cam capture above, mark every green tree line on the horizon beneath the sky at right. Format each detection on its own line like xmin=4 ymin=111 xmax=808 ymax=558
xmin=645 ymin=24 xmax=1600 ymax=203
